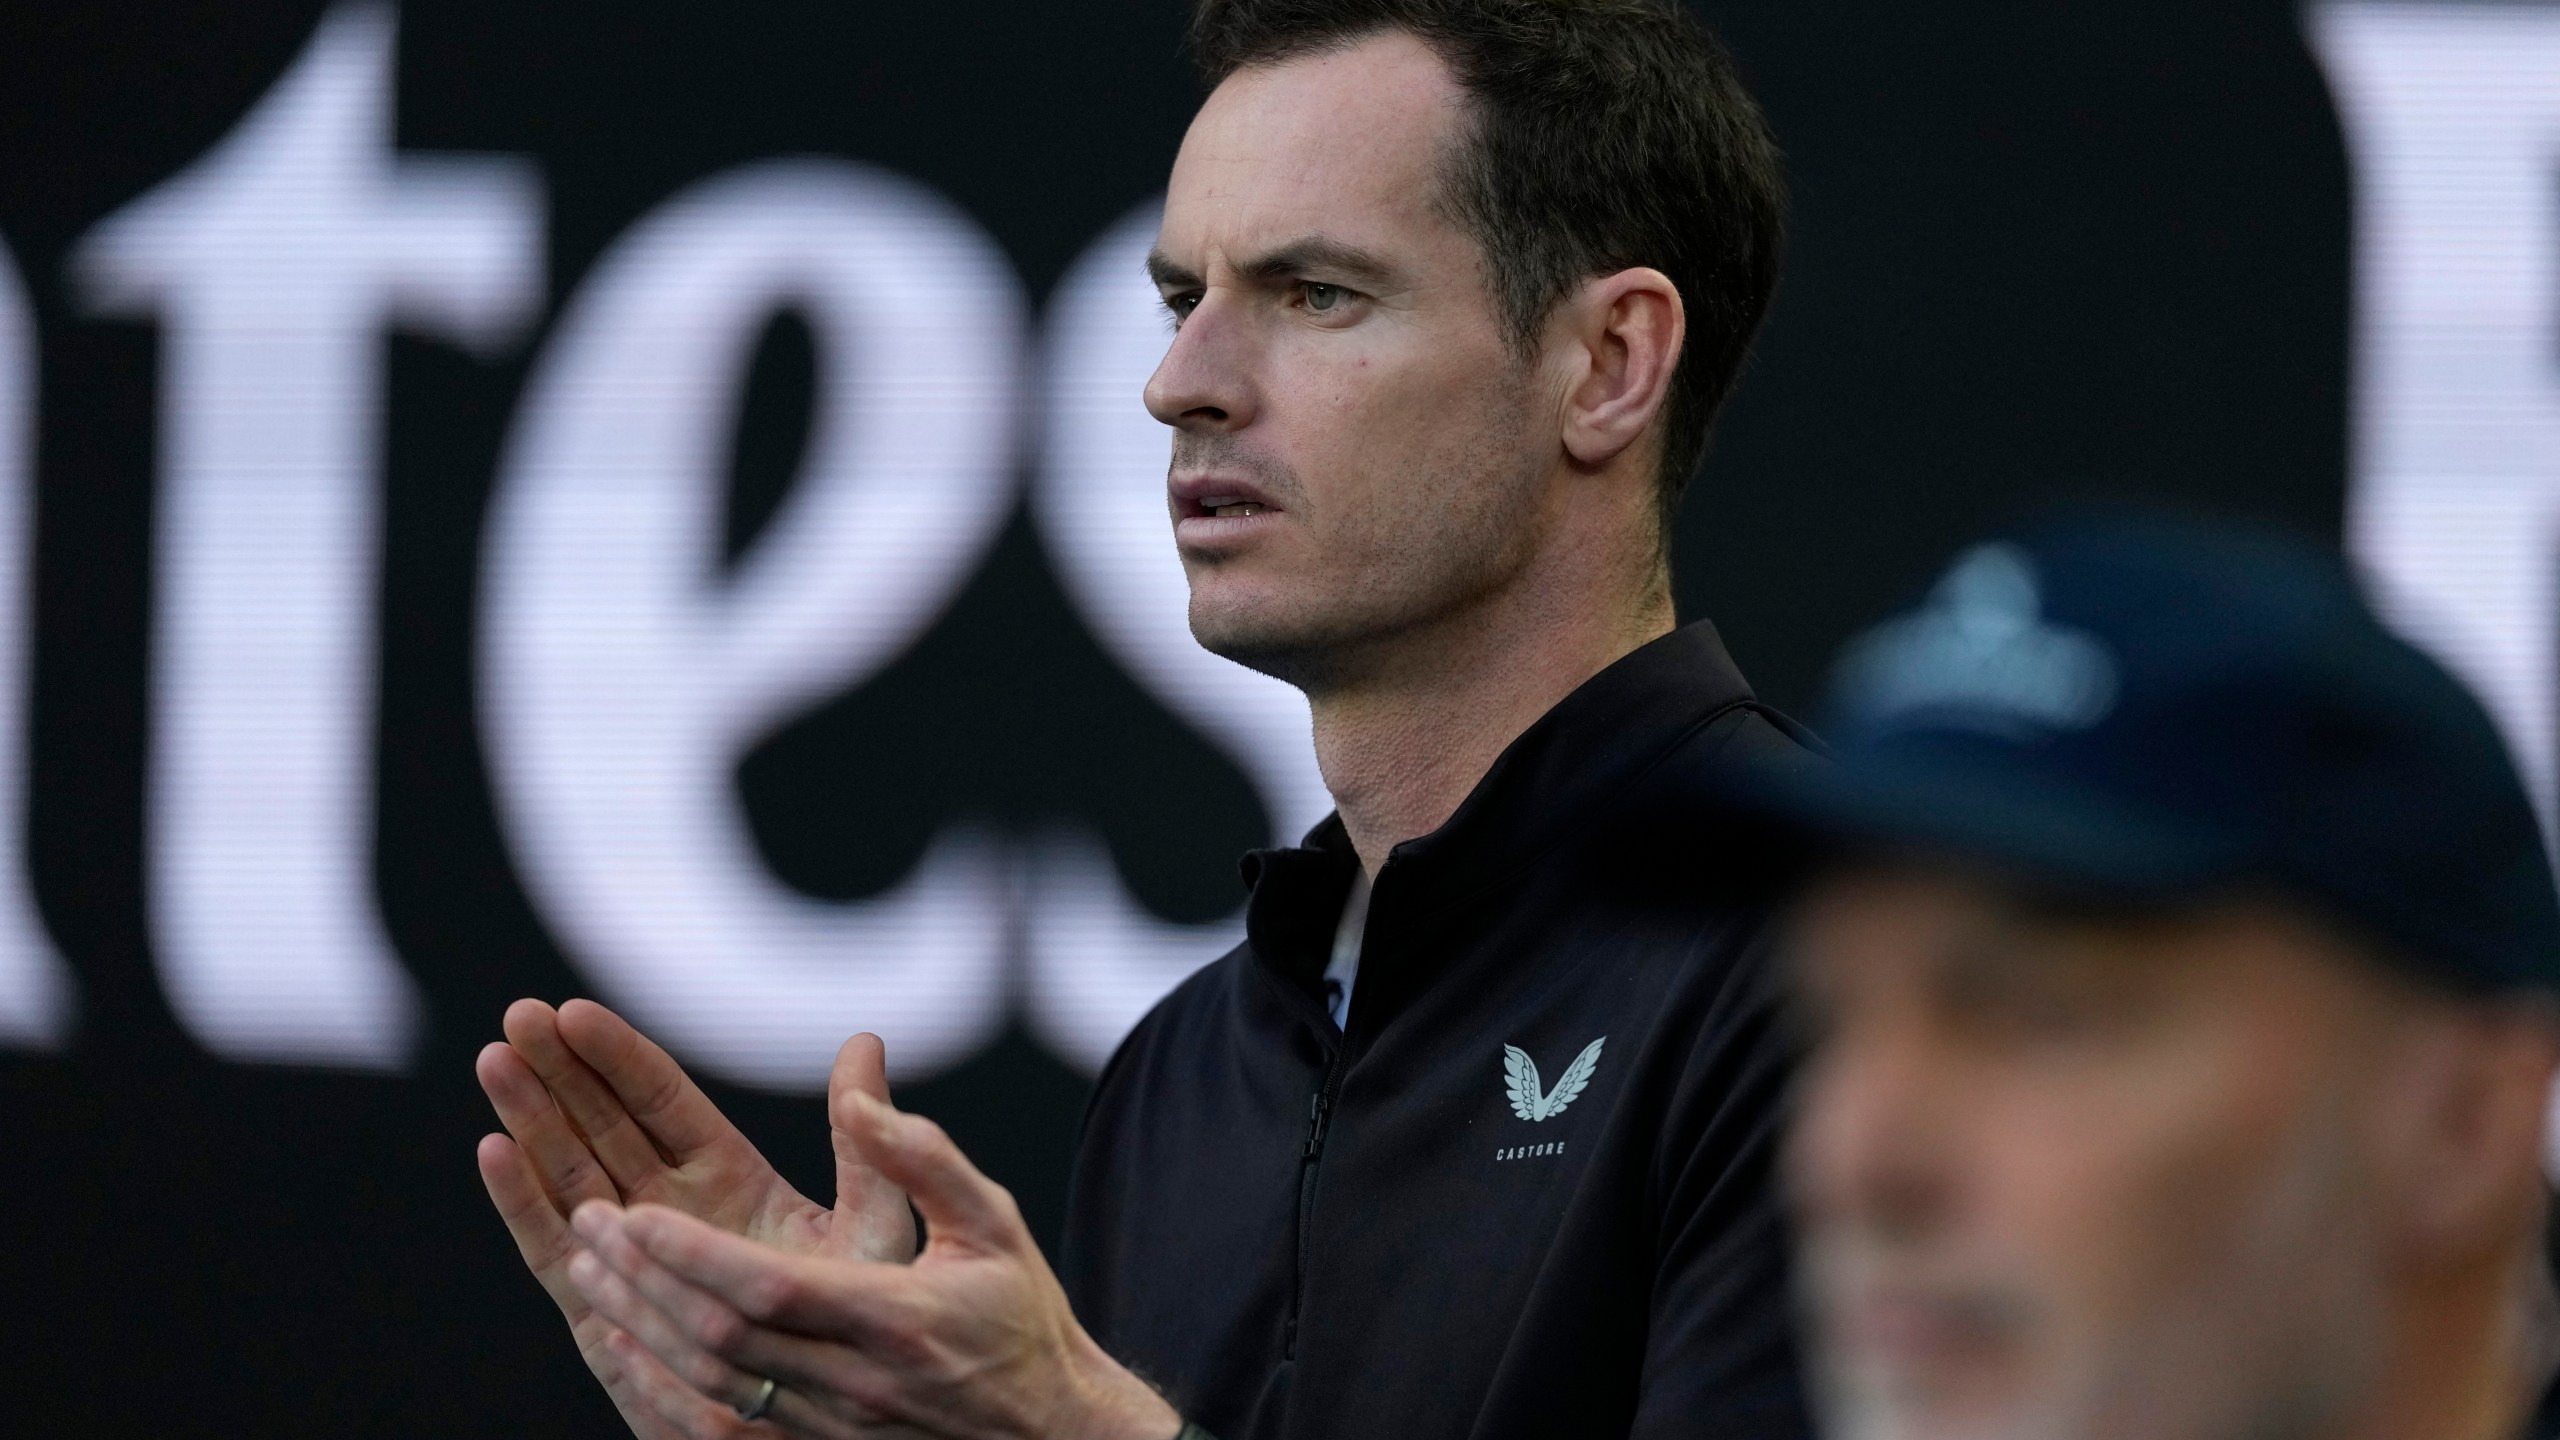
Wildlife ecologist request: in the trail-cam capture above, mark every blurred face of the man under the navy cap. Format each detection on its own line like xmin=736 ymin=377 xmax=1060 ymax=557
xmin=1789 ymin=866 xmax=2406 ymax=1440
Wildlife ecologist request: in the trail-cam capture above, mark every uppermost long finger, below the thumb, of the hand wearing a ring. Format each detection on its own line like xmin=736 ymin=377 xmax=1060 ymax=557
xmin=591 ymin=1204 xmax=916 ymax=1345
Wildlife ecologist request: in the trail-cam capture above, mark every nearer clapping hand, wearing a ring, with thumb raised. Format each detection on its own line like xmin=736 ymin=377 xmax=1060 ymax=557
xmin=568 ymin=1086 xmax=1183 ymax=1440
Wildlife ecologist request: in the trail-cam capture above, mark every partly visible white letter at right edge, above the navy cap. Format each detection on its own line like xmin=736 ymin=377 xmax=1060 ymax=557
xmin=2309 ymin=5 xmax=2560 ymax=825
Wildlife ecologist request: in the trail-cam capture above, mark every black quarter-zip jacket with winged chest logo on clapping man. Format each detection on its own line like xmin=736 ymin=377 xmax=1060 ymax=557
xmin=1060 ymin=625 xmax=1807 ymax=1440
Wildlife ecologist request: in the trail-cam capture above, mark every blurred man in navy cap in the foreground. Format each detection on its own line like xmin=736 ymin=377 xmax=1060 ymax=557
xmin=1746 ymin=515 xmax=2560 ymax=1440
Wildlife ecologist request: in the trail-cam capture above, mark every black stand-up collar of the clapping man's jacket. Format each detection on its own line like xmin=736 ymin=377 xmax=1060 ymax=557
xmin=1244 ymin=620 xmax=1751 ymax=989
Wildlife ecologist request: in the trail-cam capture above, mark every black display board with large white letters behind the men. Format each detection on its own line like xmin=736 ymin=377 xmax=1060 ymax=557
xmin=0 ymin=0 xmax=2560 ymax=1437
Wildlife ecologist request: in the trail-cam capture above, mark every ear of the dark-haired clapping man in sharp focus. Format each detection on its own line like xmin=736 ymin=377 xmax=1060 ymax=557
xmin=1556 ymin=266 xmax=1690 ymax=469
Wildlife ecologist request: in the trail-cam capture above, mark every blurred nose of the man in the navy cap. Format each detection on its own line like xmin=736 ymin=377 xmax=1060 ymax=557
xmin=1787 ymin=1033 xmax=1961 ymax=1235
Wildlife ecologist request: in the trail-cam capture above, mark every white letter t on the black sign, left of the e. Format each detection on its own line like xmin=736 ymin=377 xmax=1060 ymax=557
xmin=77 ymin=8 xmax=543 ymax=1068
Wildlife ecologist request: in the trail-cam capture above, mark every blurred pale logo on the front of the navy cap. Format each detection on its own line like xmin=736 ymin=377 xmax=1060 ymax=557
xmin=1841 ymin=543 xmax=2117 ymax=735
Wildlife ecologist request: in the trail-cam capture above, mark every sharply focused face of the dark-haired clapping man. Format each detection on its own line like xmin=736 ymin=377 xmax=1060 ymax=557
xmin=1147 ymin=33 xmax=1559 ymax=684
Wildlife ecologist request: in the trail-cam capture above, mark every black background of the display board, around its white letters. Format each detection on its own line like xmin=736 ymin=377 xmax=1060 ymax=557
xmin=0 ymin=0 xmax=2350 ymax=1440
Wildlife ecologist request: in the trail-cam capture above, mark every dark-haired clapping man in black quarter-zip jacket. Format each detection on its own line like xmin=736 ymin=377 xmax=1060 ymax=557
xmin=479 ymin=0 xmax=1805 ymax=1440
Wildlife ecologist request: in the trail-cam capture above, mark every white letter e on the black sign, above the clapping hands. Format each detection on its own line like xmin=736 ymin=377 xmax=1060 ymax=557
xmin=481 ymin=161 xmax=1021 ymax=1089
